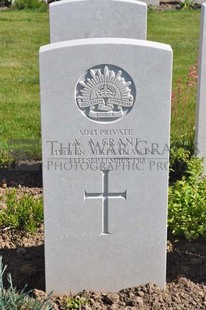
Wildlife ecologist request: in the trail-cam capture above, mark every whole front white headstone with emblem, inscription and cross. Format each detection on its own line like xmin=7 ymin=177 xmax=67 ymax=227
xmin=40 ymin=38 xmax=172 ymax=294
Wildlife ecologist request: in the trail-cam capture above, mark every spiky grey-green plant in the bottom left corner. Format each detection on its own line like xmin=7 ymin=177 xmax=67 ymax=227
xmin=0 ymin=258 xmax=53 ymax=310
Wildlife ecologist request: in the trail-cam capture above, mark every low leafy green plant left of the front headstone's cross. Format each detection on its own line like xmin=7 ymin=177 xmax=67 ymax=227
xmin=0 ymin=190 xmax=43 ymax=233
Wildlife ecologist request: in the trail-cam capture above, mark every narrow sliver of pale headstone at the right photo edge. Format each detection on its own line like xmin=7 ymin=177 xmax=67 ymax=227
xmin=195 ymin=3 xmax=206 ymax=160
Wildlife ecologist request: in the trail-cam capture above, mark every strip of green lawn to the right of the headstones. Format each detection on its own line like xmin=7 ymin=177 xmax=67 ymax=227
xmin=148 ymin=10 xmax=200 ymax=144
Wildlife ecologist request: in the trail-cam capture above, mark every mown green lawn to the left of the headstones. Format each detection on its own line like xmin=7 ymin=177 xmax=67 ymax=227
xmin=0 ymin=10 xmax=49 ymax=162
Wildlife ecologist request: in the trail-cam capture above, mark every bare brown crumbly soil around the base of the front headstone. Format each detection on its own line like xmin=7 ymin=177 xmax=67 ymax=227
xmin=0 ymin=163 xmax=206 ymax=310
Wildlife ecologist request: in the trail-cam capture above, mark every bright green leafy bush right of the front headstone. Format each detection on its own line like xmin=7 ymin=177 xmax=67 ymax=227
xmin=168 ymin=153 xmax=206 ymax=240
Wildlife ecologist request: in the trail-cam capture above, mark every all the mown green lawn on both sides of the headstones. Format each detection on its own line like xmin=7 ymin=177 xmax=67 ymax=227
xmin=0 ymin=10 xmax=200 ymax=165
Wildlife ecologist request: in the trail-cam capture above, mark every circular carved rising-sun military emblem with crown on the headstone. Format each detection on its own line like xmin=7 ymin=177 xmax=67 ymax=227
xmin=76 ymin=65 xmax=135 ymax=123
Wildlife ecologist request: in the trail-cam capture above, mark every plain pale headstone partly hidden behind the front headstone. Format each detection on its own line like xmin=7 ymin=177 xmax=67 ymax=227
xmin=50 ymin=0 xmax=147 ymax=43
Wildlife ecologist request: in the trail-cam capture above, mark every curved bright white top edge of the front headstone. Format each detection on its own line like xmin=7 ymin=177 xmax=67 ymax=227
xmin=39 ymin=38 xmax=172 ymax=53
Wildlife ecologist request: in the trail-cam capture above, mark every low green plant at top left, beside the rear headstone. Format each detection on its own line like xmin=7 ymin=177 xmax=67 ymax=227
xmin=12 ymin=0 xmax=47 ymax=11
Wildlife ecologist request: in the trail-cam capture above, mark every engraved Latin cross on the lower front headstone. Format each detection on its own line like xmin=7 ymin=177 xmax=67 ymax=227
xmin=84 ymin=170 xmax=127 ymax=235
